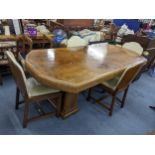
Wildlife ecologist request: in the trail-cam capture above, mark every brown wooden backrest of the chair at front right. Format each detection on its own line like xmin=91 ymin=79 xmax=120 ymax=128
xmin=116 ymin=62 xmax=145 ymax=90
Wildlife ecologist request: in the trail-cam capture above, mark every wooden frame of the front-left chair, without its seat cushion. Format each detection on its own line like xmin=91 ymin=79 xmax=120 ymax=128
xmin=7 ymin=52 xmax=62 ymax=128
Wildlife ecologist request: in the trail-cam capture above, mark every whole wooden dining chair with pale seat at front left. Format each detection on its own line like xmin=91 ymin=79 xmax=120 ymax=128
xmin=6 ymin=51 xmax=62 ymax=128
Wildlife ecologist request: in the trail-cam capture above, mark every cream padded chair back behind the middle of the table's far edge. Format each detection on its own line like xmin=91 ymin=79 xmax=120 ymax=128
xmin=67 ymin=36 xmax=88 ymax=47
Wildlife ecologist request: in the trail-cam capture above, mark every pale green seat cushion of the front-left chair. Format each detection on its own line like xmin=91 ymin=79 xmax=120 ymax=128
xmin=26 ymin=78 xmax=59 ymax=97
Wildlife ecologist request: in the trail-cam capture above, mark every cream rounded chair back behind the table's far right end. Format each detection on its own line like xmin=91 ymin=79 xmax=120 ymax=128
xmin=122 ymin=42 xmax=143 ymax=55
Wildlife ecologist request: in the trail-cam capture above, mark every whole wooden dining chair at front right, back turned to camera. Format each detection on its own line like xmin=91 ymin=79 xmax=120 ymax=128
xmin=87 ymin=63 xmax=144 ymax=116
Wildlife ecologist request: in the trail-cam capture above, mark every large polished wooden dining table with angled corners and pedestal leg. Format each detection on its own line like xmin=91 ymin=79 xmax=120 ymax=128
xmin=25 ymin=43 xmax=146 ymax=118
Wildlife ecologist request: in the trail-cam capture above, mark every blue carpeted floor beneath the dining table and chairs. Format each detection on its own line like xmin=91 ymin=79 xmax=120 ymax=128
xmin=0 ymin=73 xmax=155 ymax=135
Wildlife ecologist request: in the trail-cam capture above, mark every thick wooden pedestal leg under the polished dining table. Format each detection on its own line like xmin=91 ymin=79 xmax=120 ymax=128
xmin=61 ymin=92 xmax=78 ymax=118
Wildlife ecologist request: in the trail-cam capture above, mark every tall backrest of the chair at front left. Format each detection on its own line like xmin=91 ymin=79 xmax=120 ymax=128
xmin=6 ymin=51 xmax=28 ymax=97
